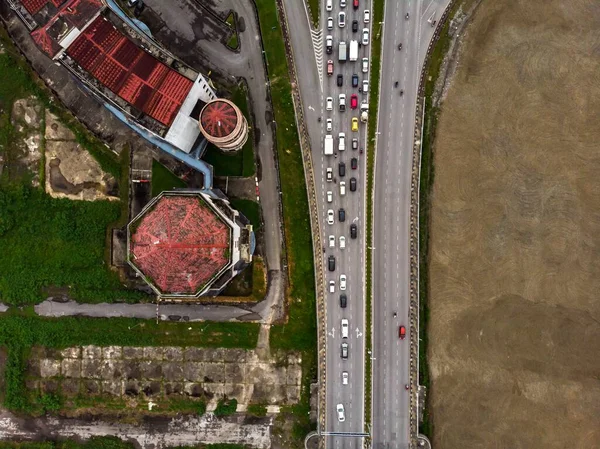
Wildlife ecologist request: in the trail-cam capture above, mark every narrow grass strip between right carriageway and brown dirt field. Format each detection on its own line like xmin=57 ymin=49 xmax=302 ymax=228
xmin=419 ymin=2 xmax=461 ymax=437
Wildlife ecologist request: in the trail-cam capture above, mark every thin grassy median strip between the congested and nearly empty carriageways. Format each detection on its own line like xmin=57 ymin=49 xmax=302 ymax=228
xmin=365 ymin=0 xmax=385 ymax=428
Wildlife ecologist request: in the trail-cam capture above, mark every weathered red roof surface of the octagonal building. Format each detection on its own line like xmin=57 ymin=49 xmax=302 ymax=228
xmin=130 ymin=196 xmax=230 ymax=294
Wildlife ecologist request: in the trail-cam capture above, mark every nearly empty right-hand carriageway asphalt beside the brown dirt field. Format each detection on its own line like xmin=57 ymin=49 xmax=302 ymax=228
xmin=372 ymin=0 xmax=449 ymax=449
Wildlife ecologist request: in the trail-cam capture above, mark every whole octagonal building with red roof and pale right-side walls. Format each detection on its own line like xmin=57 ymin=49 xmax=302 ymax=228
xmin=127 ymin=190 xmax=255 ymax=300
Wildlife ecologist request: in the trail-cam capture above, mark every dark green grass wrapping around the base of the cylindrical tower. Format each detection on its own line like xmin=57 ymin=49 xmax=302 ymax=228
xmin=202 ymin=84 xmax=256 ymax=177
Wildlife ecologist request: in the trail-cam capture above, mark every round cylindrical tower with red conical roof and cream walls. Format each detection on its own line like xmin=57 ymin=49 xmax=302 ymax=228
xmin=198 ymin=98 xmax=248 ymax=151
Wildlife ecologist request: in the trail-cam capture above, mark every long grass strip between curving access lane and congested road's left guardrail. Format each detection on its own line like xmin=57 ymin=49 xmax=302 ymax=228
xmin=250 ymin=0 xmax=318 ymax=447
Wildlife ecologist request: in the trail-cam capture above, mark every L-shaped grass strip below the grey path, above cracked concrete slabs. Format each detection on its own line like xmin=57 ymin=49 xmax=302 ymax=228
xmin=0 ymin=312 xmax=259 ymax=414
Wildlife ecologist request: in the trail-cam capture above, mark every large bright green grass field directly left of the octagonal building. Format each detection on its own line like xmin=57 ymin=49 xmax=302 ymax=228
xmin=0 ymin=182 xmax=146 ymax=304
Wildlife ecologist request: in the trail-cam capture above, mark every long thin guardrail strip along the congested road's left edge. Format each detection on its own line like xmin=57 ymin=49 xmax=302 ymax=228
xmin=276 ymin=0 xmax=327 ymax=435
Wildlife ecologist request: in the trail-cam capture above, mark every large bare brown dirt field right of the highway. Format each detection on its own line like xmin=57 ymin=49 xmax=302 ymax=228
xmin=429 ymin=0 xmax=600 ymax=449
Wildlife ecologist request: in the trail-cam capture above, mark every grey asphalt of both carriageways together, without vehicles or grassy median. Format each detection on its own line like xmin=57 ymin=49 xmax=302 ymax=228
xmin=284 ymin=0 xmax=450 ymax=449
